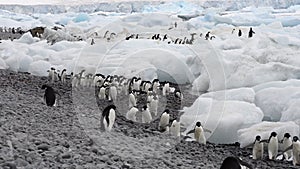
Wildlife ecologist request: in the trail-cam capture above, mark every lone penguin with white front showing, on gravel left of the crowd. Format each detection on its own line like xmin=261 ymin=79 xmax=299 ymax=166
xmin=101 ymin=105 xmax=116 ymax=131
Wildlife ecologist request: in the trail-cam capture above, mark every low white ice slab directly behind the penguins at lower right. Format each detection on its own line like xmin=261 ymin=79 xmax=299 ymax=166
xmin=238 ymin=122 xmax=299 ymax=147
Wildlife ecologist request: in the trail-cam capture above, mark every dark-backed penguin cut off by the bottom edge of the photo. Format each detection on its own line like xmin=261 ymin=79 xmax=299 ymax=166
xmin=220 ymin=156 xmax=252 ymax=169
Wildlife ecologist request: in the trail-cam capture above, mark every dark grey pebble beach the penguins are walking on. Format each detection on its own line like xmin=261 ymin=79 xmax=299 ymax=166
xmin=0 ymin=70 xmax=299 ymax=169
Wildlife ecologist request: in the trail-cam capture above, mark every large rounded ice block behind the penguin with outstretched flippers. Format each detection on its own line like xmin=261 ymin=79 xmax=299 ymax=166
xmin=180 ymin=97 xmax=263 ymax=143
